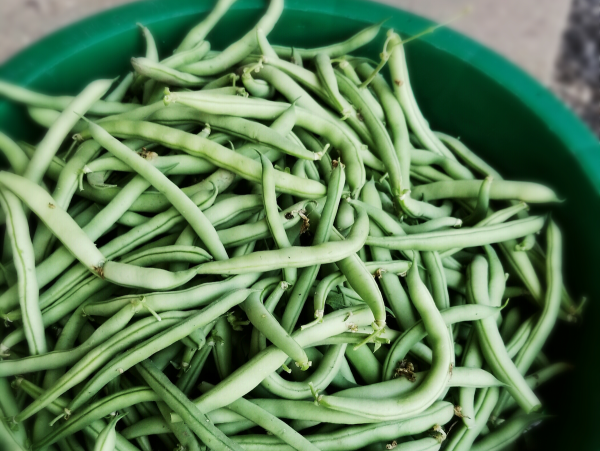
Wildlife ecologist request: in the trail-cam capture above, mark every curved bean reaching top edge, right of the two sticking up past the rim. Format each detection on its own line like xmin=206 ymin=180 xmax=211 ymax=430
xmin=182 ymin=0 xmax=283 ymax=76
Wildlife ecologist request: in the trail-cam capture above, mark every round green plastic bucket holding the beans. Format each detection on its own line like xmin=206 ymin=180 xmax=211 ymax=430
xmin=0 ymin=0 xmax=600 ymax=450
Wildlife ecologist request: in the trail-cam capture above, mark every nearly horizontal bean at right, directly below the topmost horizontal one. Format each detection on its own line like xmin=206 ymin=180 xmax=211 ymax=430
xmin=366 ymin=216 xmax=545 ymax=251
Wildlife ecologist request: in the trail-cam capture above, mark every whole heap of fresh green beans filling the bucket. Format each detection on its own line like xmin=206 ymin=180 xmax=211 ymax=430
xmin=0 ymin=0 xmax=582 ymax=451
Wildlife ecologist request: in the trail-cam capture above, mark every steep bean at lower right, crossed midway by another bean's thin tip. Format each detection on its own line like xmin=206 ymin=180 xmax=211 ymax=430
xmin=467 ymin=256 xmax=540 ymax=412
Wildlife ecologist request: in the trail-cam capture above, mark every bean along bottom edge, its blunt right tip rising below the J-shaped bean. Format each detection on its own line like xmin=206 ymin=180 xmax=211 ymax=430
xmin=234 ymin=402 xmax=454 ymax=451
